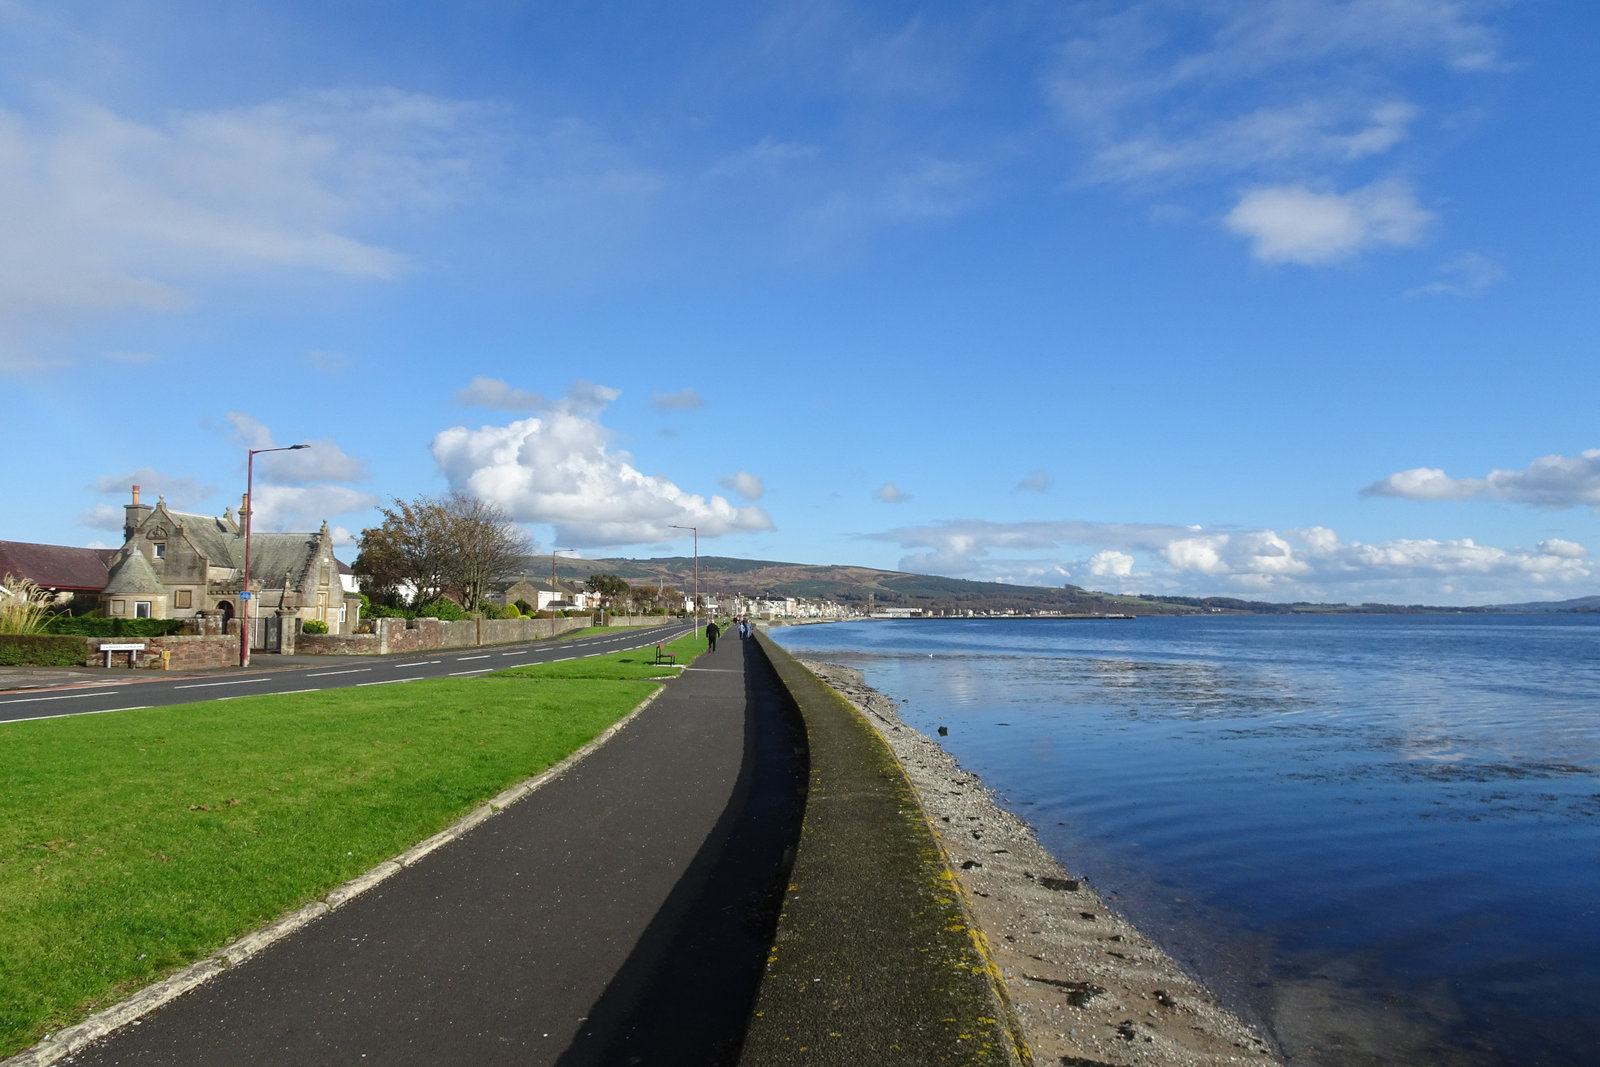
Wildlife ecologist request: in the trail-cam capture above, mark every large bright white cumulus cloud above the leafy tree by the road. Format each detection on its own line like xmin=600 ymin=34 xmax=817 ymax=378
xmin=430 ymin=382 xmax=773 ymax=547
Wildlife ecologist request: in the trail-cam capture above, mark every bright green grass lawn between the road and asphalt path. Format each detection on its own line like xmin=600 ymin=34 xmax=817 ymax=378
xmin=0 ymin=638 xmax=699 ymax=1057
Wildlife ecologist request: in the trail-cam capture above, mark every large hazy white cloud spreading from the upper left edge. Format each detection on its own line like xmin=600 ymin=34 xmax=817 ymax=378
xmin=0 ymin=90 xmax=490 ymax=365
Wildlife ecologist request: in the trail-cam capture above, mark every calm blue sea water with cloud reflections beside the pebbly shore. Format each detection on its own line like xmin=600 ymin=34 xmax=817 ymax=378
xmin=773 ymin=616 xmax=1600 ymax=1067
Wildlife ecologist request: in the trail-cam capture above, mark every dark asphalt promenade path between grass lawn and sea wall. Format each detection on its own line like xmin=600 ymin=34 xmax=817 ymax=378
xmin=67 ymin=637 xmax=805 ymax=1067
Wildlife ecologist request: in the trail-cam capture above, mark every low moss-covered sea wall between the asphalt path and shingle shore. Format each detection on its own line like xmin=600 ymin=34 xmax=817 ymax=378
xmin=739 ymin=635 xmax=1032 ymax=1067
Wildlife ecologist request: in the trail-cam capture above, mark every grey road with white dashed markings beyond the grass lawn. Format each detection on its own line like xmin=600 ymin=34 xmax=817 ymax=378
xmin=0 ymin=622 xmax=690 ymax=723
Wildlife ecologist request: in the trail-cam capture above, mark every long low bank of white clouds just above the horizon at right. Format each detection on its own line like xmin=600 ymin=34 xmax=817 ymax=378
xmin=872 ymin=520 xmax=1595 ymax=603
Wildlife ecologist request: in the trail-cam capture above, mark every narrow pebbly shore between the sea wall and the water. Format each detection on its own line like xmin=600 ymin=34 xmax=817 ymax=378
xmin=805 ymin=662 xmax=1282 ymax=1067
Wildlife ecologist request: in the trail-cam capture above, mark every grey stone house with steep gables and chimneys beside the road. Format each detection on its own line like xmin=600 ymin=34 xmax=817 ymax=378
xmin=101 ymin=486 xmax=360 ymax=633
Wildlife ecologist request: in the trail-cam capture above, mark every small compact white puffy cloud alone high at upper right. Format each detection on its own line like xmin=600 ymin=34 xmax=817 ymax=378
xmin=1226 ymin=181 xmax=1434 ymax=266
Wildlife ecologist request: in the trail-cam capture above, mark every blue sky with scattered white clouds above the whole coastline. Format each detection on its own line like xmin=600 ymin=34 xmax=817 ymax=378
xmin=0 ymin=0 xmax=1600 ymax=603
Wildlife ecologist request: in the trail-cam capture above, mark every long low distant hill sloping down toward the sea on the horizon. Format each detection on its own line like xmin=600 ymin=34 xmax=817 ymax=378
xmin=540 ymin=555 xmax=1510 ymax=614
